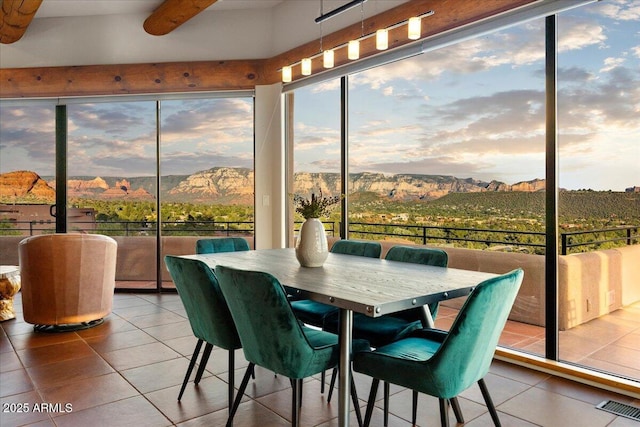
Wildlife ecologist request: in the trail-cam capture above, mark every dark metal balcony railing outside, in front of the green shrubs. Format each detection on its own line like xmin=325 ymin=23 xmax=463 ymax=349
xmin=0 ymin=220 xmax=640 ymax=255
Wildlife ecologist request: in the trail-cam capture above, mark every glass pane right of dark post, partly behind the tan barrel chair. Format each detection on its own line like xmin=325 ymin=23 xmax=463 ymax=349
xmin=67 ymin=102 xmax=158 ymax=289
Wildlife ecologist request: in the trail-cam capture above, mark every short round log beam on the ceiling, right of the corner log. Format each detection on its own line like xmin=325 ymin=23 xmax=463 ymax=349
xmin=143 ymin=0 xmax=217 ymax=36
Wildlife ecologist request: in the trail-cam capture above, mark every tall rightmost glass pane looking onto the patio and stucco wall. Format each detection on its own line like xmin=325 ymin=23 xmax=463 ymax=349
xmin=558 ymin=1 xmax=640 ymax=381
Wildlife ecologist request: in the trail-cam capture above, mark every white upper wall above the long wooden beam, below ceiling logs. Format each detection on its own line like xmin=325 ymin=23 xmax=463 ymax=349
xmin=0 ymin=0 xmax=406 ymax=68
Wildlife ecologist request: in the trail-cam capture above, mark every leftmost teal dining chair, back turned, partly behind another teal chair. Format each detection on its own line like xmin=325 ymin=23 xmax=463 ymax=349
xmin=164 ymin=255 xmax=251 ymax=424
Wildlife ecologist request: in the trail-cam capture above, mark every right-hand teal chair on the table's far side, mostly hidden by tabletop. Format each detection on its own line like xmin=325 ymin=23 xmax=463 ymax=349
xmin=326 ymin=245 xmax=450 ymax=426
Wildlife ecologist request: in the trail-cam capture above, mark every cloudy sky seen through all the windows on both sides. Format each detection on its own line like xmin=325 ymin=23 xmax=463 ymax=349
xmin=0 ymin=0 xmax=640 ymax=191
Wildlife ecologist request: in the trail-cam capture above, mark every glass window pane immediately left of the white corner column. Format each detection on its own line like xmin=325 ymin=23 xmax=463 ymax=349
xmin=160 ymin=97 xmax=254 ymax=288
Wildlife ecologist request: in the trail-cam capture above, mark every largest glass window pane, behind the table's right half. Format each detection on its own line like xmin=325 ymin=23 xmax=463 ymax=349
xmin=349 ymin=19 xmax=545 ymax=354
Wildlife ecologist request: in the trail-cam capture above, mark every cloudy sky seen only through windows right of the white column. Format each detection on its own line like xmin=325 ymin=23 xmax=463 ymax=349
xmin=295 ymin=0 xmax=640 ymax=191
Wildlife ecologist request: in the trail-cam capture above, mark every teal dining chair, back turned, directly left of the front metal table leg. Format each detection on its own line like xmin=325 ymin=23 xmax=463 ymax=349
xmin=215 ymin=265 xmax=369 ymax=426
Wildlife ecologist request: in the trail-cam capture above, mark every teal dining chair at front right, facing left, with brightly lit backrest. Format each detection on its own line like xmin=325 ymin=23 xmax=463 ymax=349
xmin=353 ymin=269 xmax=524 ymax=427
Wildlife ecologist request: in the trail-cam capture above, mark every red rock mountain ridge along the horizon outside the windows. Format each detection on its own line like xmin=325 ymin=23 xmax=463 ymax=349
xmin=0 ymin=167 xmax=638 ymax=204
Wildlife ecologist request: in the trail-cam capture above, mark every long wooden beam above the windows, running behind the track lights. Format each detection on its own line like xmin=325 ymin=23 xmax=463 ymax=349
xmin=0 ymin=0 xmax=537 ymax=98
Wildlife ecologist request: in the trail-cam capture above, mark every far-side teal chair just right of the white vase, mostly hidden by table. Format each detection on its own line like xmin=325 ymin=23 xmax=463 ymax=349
xmin=291 ymin=240 xmax=382 ymax=332
